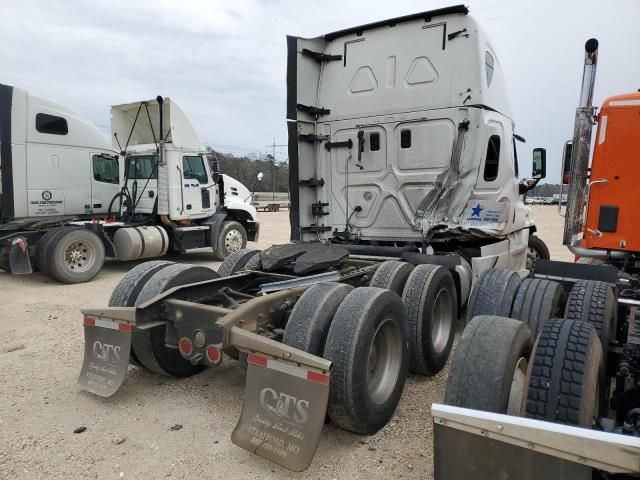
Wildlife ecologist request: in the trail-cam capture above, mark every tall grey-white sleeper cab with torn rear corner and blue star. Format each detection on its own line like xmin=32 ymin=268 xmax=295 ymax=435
xmin=287 ymin=6 xmax=534 ymax=284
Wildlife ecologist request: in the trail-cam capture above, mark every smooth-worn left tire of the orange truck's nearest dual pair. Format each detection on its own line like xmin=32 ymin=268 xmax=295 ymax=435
xmin=444 ymin=315 xmax=533 ymax=415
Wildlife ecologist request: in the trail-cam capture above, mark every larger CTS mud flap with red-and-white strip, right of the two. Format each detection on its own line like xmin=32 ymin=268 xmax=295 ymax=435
xmin=231 ymin=354 xmax=329 ymax=472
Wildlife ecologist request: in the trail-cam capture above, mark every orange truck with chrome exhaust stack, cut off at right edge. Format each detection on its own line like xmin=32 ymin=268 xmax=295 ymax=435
xmin=432 ymin=39 xmax=640 ymax=480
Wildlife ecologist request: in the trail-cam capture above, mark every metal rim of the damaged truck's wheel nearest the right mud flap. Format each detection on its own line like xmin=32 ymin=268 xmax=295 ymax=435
xmin=367 ymin=319 xmax=402 ymax=405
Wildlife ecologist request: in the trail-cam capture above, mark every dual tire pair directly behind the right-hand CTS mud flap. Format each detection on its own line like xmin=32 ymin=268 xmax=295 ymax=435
xmin=283 ymin=283 xmax=408 ymax=435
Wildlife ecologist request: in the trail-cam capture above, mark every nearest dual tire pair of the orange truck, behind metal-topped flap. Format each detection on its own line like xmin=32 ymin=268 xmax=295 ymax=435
xmin=444 ymin=316 xmax=603 ymax=427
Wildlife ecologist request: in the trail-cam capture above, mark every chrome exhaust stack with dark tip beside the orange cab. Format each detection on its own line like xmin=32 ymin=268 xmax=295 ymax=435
xmin=563 ymin=38 xmax=598 ymax=249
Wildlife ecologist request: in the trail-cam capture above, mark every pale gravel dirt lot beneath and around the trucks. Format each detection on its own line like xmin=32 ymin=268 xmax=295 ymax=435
xmin=0 ymin=206 xmax=571 ymax=480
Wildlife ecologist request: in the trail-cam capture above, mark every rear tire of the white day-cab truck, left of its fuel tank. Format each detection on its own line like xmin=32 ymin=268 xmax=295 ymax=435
xmin=38 ymin=227 xmax=105 ymax=284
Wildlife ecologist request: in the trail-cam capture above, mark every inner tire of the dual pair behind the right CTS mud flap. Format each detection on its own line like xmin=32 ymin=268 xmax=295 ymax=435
xmin=282 ymin=283 xmax=353 ymax=356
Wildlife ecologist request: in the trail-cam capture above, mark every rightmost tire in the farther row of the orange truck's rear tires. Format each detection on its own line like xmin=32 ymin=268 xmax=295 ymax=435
xmin=564 ymin=280 xmax=618 ymax=351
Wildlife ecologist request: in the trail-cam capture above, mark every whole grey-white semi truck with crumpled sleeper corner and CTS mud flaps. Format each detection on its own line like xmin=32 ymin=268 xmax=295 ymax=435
xmin=79 ymin=5 xmax=546 ymax=471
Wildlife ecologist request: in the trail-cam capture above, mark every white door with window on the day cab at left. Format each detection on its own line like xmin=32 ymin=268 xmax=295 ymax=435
xmin=181 ymin=154 xmax=216 ymax=218
